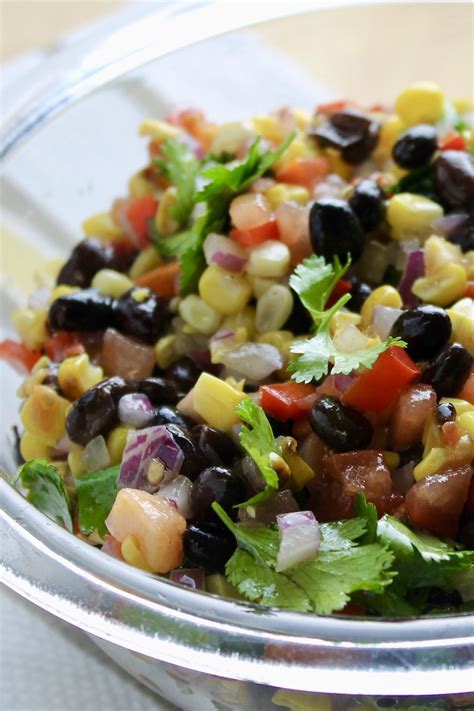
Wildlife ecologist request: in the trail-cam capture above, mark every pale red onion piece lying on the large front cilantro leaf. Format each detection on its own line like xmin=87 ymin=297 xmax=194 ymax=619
xmin=275 ymin=511 xmax=320 ymax=573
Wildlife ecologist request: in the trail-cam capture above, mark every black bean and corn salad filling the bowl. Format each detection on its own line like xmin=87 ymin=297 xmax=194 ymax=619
xmin=0 ymin=82 xmax=474 ymax=617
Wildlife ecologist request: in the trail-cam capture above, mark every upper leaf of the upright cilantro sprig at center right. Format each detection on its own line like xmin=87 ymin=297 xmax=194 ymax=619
xmin=290 ymin=255 xmax=351 ymax=320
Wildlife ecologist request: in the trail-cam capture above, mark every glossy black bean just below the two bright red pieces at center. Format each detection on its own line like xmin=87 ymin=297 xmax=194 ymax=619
xmin=309 ymin=396 xmax=373 ymax=452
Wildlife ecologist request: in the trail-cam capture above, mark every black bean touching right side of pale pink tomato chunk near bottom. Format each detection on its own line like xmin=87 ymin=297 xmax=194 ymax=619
xmin=183 ymin=522 xmax=237 ymax=572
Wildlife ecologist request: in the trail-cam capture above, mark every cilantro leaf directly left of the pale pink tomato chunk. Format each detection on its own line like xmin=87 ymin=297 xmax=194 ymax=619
xmin=76 ymin=465 xmax=120 ymax=536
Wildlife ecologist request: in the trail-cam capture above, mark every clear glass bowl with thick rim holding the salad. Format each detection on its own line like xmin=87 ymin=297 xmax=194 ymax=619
xmin=0 ymin=2 xmax=474 ymax=711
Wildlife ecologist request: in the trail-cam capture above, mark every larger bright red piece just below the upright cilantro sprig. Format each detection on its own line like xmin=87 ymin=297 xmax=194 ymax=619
xmin=342 ymin=346 xmax=421 ymax=412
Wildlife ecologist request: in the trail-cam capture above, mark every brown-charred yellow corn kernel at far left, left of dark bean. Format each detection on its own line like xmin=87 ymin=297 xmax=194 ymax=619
xmin=20 ymin=385 xmax=71 ymax=446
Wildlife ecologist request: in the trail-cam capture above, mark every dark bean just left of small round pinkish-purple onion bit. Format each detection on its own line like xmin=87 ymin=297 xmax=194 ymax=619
xmin=66 ymin=376 xmax=134 ymax=446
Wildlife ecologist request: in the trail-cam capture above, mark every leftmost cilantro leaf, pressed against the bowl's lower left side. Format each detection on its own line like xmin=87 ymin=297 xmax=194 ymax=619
xmin=18 ymin=459 xmax=72 ymax=531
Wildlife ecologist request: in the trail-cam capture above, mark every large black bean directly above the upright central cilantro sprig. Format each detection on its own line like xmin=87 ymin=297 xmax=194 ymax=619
xmin=309 ymin=199 xmax=364 ymax=262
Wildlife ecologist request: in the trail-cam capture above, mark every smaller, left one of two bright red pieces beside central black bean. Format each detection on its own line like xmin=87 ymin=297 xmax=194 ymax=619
xmin=260 ymin=380 xmax=317 ymax=422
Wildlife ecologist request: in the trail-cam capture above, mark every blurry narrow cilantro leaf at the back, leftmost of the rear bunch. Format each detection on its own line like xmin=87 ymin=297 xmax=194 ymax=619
xmin=154 ymin=138 xmax=200 ymax=225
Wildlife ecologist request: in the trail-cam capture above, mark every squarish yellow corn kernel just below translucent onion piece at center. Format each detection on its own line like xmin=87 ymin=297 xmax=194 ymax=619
xmin=194 ymin=373 xmax=247 ymax=430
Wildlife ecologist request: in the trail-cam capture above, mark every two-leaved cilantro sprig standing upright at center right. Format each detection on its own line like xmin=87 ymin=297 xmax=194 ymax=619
xmin=288 ymin=256 xmax=406 ymax=383
